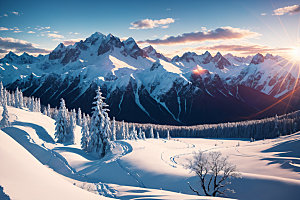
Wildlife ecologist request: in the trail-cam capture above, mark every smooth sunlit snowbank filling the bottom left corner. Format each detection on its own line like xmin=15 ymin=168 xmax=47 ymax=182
xmin=0 ymin=130 xmax=109 ymax=200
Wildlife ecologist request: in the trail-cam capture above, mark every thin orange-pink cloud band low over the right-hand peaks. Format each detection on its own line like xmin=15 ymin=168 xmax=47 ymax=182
xmin=196 ymin=44 xmax=291 ymax=55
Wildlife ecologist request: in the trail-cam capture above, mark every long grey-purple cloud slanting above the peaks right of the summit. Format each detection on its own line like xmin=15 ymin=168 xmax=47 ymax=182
xmin=139 ymin=26 xmax=260 ymax=45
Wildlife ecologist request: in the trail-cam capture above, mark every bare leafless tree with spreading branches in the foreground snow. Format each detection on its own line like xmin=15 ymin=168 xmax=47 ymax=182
xmin=186 ymin=151 xmax=240 ymax=196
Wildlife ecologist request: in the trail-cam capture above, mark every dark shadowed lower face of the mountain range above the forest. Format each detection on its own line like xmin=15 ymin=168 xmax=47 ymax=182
xmin=8 ymin=70 xmax=284 ymax=125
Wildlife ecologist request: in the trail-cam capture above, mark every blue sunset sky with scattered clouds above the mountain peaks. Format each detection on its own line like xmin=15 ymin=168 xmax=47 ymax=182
xmin=0 ymin=0 xmax=300 ymax=57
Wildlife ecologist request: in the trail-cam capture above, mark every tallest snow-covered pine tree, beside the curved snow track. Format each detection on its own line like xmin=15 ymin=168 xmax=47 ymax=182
xmin=87 ymin=87 xmax=109 ymax=157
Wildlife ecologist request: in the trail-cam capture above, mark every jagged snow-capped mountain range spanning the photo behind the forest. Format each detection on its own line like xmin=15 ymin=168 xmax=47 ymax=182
xmin=0 ymin=32 xmax=296 ymax=125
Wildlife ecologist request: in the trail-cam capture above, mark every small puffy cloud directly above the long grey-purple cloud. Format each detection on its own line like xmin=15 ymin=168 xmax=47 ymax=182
xmin=129 ymin=18 xmax=175 ymax=29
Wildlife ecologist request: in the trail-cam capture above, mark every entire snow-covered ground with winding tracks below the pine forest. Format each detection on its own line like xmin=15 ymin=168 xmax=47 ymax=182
xmin=0 ymin=107 xmax=300 ymax=200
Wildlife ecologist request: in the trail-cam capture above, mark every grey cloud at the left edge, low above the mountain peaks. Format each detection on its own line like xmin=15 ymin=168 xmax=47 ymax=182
xmin=0 ymin=37 xmax=50 ymax=53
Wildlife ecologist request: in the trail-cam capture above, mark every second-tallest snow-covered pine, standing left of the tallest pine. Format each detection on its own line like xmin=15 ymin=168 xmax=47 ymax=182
xmin=54 ymin=99 xmax=68 ymax=143
